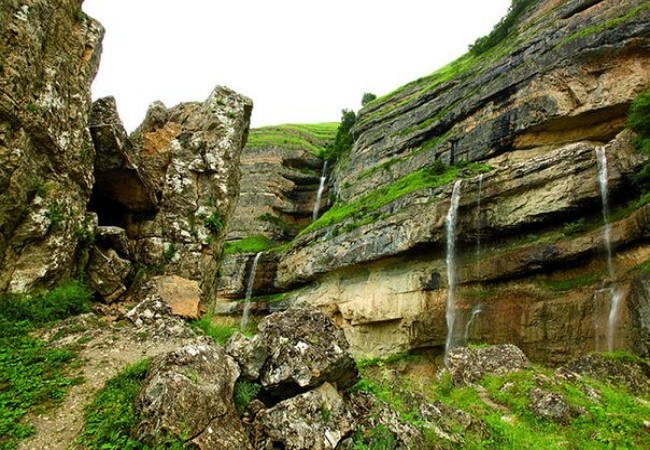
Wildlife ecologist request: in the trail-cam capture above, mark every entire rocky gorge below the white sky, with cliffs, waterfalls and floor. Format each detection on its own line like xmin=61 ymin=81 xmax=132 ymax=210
xmin=0 ymin=0 xmax=650 ymax=450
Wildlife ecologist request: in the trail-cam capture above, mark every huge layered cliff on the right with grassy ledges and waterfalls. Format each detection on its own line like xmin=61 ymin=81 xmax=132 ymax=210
xmin=218 ymin=0 xmax=650 ymax=362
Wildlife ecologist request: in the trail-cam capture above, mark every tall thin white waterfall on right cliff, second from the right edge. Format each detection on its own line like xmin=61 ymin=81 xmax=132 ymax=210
xmin=445 ymin=180 xmax=461 ymax=360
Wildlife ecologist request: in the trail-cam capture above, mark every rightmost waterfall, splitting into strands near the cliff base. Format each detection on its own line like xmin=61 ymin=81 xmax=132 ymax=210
xmin=594 ymin=147 xmax=623 ymax=352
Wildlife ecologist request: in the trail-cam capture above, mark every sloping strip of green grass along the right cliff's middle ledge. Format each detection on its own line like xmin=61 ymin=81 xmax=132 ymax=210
xmin=299 ymin=163 xmax=490 ymax=236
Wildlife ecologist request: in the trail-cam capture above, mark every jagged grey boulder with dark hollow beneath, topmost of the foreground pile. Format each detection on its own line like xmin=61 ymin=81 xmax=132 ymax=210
xmin=226 ymin=305 xmax=358 ymax=398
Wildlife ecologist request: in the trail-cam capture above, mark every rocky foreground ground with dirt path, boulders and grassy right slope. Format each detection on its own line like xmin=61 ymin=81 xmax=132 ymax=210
xmin=12 ymin=297 xmax=650 ymax=450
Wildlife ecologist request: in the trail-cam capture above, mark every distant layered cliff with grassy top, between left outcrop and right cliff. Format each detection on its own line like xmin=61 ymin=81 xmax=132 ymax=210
xmin=219 ymin=123 xmax=338 ymax=298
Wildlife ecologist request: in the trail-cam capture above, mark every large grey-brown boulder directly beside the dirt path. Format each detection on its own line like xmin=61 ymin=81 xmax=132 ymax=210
xmin=136 ymin=338 xmax=249 ymax=450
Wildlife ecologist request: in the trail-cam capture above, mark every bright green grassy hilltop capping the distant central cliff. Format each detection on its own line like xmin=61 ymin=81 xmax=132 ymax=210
xmin=246 ymin=122 xmax=338 ymax=156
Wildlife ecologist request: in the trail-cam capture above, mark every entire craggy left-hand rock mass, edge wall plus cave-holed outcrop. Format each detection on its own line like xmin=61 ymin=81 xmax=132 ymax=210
xmin=0 ymin=0 xmax=252 ymax=302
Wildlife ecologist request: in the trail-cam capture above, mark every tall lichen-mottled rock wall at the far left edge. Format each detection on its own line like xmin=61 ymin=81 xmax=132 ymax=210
xmin=0 ymin=0 xmax=103 ymax=292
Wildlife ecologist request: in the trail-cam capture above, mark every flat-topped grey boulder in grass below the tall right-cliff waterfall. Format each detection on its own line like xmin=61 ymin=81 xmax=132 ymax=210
xmin=447 ymin=344 xmax=530 ymax=384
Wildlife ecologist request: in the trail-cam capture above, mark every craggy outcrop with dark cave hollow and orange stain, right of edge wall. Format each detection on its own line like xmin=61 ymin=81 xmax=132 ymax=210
xmin=89 ymin=87 xmax=252 ymax=301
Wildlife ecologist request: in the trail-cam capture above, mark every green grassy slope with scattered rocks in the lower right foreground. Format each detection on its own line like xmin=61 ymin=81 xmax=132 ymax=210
xmin=352 ymin=354 xmax=650 ymax=450
